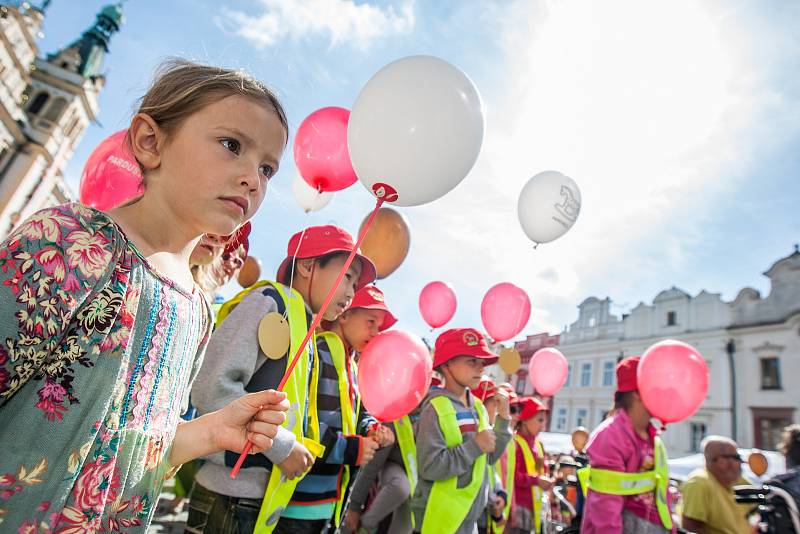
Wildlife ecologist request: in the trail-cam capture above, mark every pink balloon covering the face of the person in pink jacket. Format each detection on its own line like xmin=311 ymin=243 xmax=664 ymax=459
xmin=636 ymin=339 xmax=708 ymax=424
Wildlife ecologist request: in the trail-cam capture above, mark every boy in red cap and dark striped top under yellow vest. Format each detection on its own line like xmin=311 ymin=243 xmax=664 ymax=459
xmin=276 ymin=285 xmax=397 ymax=532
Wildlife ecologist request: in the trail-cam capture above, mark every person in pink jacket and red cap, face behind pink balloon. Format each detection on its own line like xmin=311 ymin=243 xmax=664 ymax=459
xmin=581 ymin=356 xmax=675 ymax=534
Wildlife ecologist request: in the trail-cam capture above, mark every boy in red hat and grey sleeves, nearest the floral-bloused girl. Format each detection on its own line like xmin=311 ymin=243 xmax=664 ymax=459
xmin=187 ymin=225 xmax=375 ymax=533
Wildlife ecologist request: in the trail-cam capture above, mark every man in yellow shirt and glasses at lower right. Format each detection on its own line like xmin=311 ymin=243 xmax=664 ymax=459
xmin=681 ymin=436 xmax=753 ymax=534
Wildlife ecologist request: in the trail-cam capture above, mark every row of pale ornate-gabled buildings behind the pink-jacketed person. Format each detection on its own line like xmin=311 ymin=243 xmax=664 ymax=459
xmin=551 ymin=251 xmax=800 ymax=456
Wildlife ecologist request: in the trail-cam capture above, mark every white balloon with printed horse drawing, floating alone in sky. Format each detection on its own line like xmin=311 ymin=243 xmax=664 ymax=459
xmin=517 ymin=171 xmax=581 ymax=244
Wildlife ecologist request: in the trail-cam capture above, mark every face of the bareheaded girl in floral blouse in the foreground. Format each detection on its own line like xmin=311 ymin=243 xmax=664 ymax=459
xmin=152 ymin=95 xmax=286 ymax=235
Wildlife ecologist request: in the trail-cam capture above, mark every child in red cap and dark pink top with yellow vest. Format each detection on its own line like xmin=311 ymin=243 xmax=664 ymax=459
xmin=506 ymin=397 xmax=553 ymax=534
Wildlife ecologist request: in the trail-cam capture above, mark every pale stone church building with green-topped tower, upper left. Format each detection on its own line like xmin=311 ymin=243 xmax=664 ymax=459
xmin=0 ymin=0 xmax=124 ymax=239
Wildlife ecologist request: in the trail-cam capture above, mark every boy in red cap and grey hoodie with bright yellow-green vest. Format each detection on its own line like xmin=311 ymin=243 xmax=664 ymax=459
xmin=412 ymin=328 xmax=511 ymax=534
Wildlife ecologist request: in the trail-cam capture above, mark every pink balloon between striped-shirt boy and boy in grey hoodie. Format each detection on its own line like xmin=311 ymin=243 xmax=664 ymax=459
xmin=358 ymin=330 xmax=433 ymax=422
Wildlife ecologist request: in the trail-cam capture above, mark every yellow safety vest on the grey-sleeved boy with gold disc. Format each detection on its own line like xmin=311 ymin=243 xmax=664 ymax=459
xmin=217 ymin=280 xmax=325 ymax=534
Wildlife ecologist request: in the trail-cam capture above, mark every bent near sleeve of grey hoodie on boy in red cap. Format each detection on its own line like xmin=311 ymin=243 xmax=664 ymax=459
xmin=417 ymin=403 xmax=483 ymax=480
